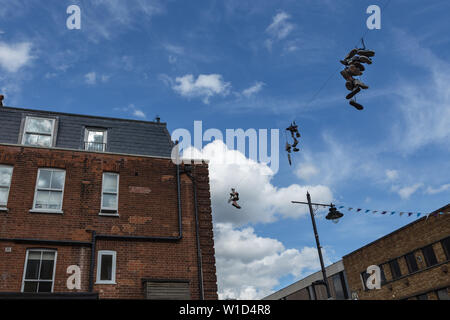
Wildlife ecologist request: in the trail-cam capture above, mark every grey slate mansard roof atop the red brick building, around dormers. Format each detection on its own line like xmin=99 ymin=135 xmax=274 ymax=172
xmin=0 ymin=107 xmax=173 ymax=157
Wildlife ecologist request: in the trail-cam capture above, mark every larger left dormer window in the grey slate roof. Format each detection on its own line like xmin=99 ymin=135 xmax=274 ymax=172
xmin=22 ymin=117 xmax=56 ymax=147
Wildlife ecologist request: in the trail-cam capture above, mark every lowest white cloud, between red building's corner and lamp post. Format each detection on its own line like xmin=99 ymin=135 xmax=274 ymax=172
xmin=214 ymin=223 xmax=329 ymax=300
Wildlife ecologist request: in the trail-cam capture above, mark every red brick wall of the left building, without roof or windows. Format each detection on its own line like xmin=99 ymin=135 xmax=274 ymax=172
xmin=0 ymin=145 xmax=217 ymax=299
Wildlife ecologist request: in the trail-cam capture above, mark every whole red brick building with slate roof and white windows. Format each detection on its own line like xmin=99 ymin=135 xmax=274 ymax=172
xmin=0 ymin=107 xmax=217 ymax=299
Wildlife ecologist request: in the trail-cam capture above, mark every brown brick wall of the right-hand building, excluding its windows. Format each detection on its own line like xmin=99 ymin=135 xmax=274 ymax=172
xmin=343 ymin=205 xmax=450 ymax=300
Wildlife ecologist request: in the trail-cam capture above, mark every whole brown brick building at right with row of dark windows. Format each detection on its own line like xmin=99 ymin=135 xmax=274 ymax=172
xmin=343 ymin=204 xmax=450 ymax=300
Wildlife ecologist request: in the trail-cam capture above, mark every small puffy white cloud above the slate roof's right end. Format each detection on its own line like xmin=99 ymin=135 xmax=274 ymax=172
xmin=172 ymin=74 xmax=231 ymax=104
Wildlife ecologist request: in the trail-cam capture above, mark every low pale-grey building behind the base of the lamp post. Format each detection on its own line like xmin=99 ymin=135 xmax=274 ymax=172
xmin=263 ymin=260 xmax=350 ymax=300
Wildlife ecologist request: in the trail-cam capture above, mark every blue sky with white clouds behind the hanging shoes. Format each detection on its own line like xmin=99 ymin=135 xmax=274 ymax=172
xmin=0 ymin=0 xmax=450 ymax=299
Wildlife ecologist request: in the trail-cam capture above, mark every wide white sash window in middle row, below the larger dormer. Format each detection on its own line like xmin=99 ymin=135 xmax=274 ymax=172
xmin=32 ymin=169 xmax=66 ymax=213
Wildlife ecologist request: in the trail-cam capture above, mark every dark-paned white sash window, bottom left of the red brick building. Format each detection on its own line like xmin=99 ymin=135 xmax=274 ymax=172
xmin=22 ymin=249 xmax=56 ymax=292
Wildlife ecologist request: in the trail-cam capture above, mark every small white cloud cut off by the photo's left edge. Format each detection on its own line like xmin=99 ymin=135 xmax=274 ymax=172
xmin=0 ymin=42 xmax=32 ymax=72
